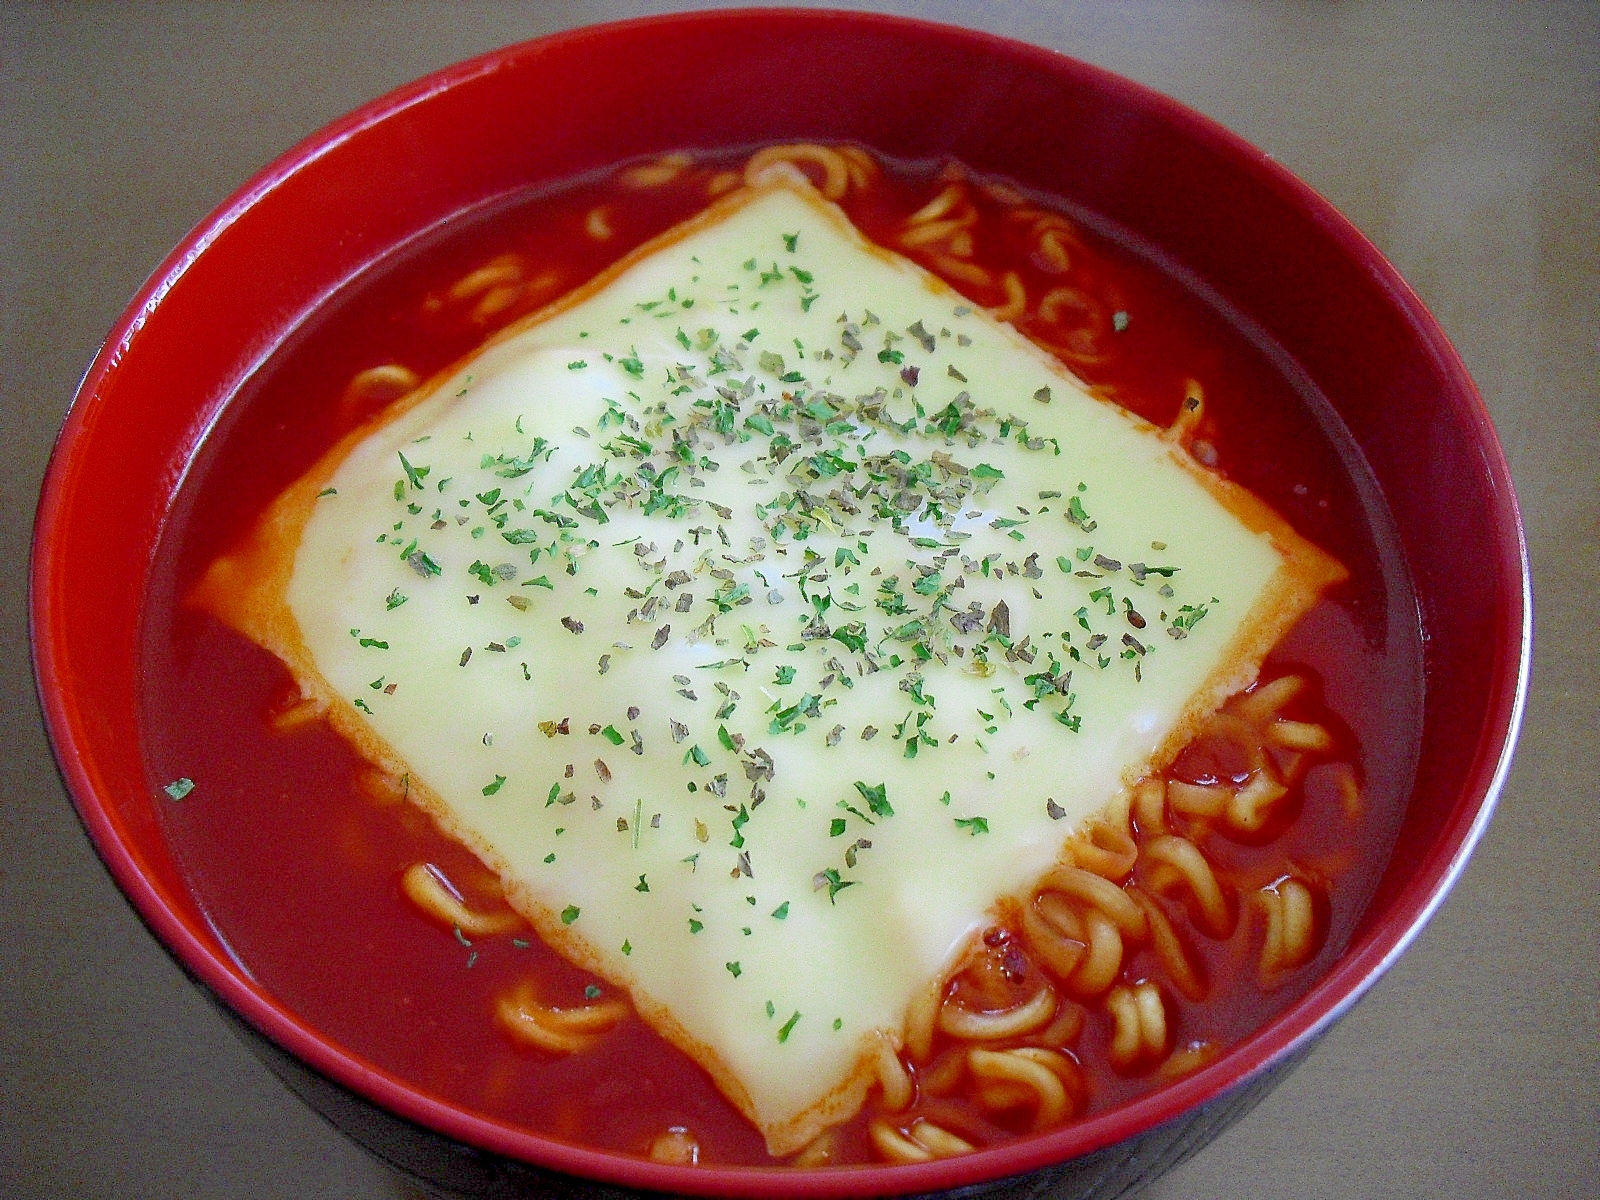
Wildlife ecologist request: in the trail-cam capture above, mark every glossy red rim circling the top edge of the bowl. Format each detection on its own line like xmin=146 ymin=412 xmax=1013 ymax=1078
xmin=29 ymin=8 xmax=1533 ymax=1197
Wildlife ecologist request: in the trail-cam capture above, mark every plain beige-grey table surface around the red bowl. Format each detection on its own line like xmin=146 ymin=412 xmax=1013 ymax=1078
xmin=0 ymin=0 xmax=1600 ymax=1200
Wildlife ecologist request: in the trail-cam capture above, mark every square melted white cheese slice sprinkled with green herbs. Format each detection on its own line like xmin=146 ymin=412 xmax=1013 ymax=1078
xmin=195 ymin=174 xmax=1341 ymax=1154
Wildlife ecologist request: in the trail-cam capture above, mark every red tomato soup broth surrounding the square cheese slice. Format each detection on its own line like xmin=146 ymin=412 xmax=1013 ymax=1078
xmin=142 ymin=152 xmax=1421 ymax=1165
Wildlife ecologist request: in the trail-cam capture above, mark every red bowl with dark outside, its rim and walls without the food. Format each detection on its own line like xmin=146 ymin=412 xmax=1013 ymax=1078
xmin=30 ymin=10 xmax=1531 ymax=1197
